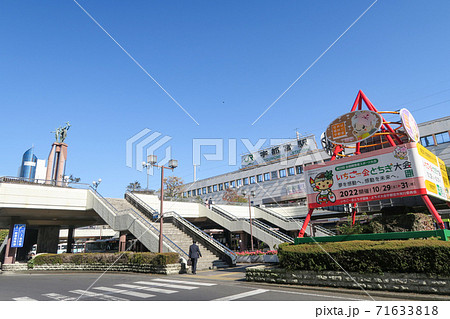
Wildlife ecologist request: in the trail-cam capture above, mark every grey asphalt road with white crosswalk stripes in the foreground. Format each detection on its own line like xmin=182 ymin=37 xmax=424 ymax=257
xmin=0 ymin=266 xmax=449 ymax=302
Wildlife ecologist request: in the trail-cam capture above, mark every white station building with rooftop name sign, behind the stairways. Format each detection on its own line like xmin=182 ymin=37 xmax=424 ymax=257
xmin=183 ymin=135 xmax=330 ymax=205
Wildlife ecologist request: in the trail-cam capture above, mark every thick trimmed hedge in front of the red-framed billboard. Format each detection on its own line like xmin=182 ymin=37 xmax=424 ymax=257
xmin=278 ymin=239 xmax=450 ymax=276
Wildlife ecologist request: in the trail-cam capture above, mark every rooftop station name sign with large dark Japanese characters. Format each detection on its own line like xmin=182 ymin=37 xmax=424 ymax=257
xmin=241 ymin=135 xmax=317 ymax=168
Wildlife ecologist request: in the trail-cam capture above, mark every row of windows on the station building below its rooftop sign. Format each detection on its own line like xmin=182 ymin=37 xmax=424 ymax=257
xmin=183 ymin=165 xmax=303 ymax=197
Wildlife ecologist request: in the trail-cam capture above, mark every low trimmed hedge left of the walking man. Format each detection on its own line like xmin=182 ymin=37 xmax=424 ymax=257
xmin=30 ymin=252 xmax=180 ymax=266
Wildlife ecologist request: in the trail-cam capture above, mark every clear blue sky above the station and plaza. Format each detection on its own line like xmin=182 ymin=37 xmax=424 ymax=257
xmin=0 ymin=0 xmax=450 ymax=197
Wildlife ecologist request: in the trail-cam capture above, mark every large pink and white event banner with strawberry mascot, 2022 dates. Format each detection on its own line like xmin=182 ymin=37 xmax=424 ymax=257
xmin=305 ymin=143 xmax=450 ymax=208
